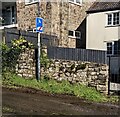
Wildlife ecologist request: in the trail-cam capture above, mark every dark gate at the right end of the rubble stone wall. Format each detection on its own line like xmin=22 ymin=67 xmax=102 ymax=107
xmin=108 ymin=55 xmax=120 ymax=95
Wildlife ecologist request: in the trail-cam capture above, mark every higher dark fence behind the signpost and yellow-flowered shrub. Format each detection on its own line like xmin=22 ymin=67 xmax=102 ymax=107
xmin=4 ymin=28 xmax=59 ymax=47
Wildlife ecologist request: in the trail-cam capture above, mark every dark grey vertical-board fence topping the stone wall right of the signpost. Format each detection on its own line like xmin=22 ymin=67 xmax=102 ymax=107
xmin=47 ymin=46 xmax=107 ymax=64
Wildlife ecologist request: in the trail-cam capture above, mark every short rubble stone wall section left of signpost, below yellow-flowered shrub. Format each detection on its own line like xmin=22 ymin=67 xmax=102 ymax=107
xmin=16 ymin=49 xmax=35 ymax=78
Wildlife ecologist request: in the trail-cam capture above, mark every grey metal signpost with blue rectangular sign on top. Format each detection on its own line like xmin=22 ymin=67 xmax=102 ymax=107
xmin=36 ymin=17 xmax=43 ymax=81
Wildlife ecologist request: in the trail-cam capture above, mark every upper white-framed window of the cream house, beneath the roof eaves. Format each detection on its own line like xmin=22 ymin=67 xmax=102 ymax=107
xmin=107 ymin=12 xmax=120 ymax=26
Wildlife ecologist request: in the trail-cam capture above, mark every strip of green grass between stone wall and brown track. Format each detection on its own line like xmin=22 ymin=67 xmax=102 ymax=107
xmin=2 ymin=73 xmax=118 ymax=102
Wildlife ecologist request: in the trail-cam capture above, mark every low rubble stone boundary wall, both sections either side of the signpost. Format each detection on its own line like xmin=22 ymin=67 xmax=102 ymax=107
xmin=16 ymin=49 xmax=109 ymax=94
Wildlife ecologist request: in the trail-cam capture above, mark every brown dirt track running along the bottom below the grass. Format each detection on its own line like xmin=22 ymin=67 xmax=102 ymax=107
xmin=2 ymin=88 xmax=119 ymax=115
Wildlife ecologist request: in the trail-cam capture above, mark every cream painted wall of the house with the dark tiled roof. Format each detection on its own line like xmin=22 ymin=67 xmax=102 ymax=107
xmin=86 ymin=10 xmax=120 ymax=50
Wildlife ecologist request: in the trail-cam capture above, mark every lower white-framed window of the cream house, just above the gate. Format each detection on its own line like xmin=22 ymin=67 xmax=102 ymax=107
xmin=107 ymin=41 xmax=120 ymax=55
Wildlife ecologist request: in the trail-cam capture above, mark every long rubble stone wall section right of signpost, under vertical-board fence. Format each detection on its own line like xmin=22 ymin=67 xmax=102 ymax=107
xmin=41 ymin=60 xmax=108 ymax=94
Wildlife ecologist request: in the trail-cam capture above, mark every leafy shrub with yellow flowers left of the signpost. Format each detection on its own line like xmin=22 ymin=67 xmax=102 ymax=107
xmin=0 ymin=37 xmax=34 ymax=73
